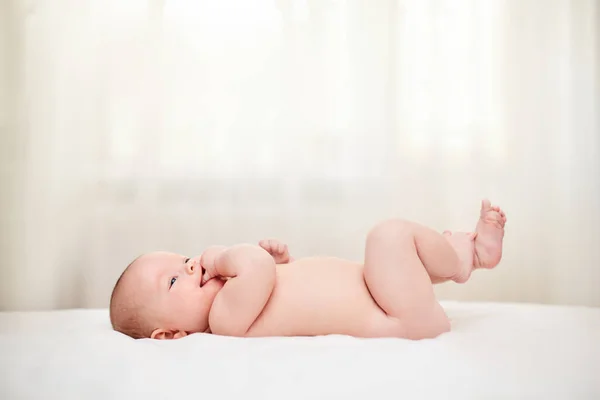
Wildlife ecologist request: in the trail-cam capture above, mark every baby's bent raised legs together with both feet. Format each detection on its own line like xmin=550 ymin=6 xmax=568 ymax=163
xmin=364 ymin=199 xmax=506 ymax=339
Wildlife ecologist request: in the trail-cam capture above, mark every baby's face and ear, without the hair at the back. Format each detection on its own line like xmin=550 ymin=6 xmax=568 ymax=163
xmin=128 ymin=252 xmax=224 ymax=338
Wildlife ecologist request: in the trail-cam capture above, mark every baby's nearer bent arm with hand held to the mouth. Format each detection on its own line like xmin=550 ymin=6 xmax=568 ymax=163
xmin=207 ymin=245 xmax=275 ymax=336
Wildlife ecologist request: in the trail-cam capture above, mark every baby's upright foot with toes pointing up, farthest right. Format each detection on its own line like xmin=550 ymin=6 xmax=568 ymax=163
xmin=474 ymin=199 xmax=506 ymax=268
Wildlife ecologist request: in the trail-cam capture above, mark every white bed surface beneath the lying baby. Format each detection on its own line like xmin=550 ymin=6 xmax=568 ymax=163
xmin=0 ymin=302 xmax=600 ymax=400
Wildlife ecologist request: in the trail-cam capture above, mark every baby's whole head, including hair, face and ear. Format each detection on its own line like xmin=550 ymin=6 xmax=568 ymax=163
xmin=110 ymin=252 xmax=224 ymax=339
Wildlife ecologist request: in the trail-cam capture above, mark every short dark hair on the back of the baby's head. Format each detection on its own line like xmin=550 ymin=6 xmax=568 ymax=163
xmin=109 ymin=257 xmax=152 ymax=339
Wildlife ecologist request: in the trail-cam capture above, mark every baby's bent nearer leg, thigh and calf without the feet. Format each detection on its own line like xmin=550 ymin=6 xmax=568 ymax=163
xmin=364 ymin=220 xmax=463 ymax=339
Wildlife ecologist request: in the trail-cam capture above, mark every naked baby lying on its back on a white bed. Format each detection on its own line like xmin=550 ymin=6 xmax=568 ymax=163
xmin=110 ymin=200 xmax=506 ymax=340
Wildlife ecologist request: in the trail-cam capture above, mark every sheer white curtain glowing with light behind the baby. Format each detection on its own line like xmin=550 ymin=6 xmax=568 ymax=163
xmin=0 ymin=0 xmax=600 ymax=310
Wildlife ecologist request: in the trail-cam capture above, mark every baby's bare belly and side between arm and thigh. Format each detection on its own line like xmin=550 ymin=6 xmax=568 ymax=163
xmin=248 ymin=258 xmax=389 ymax=337
